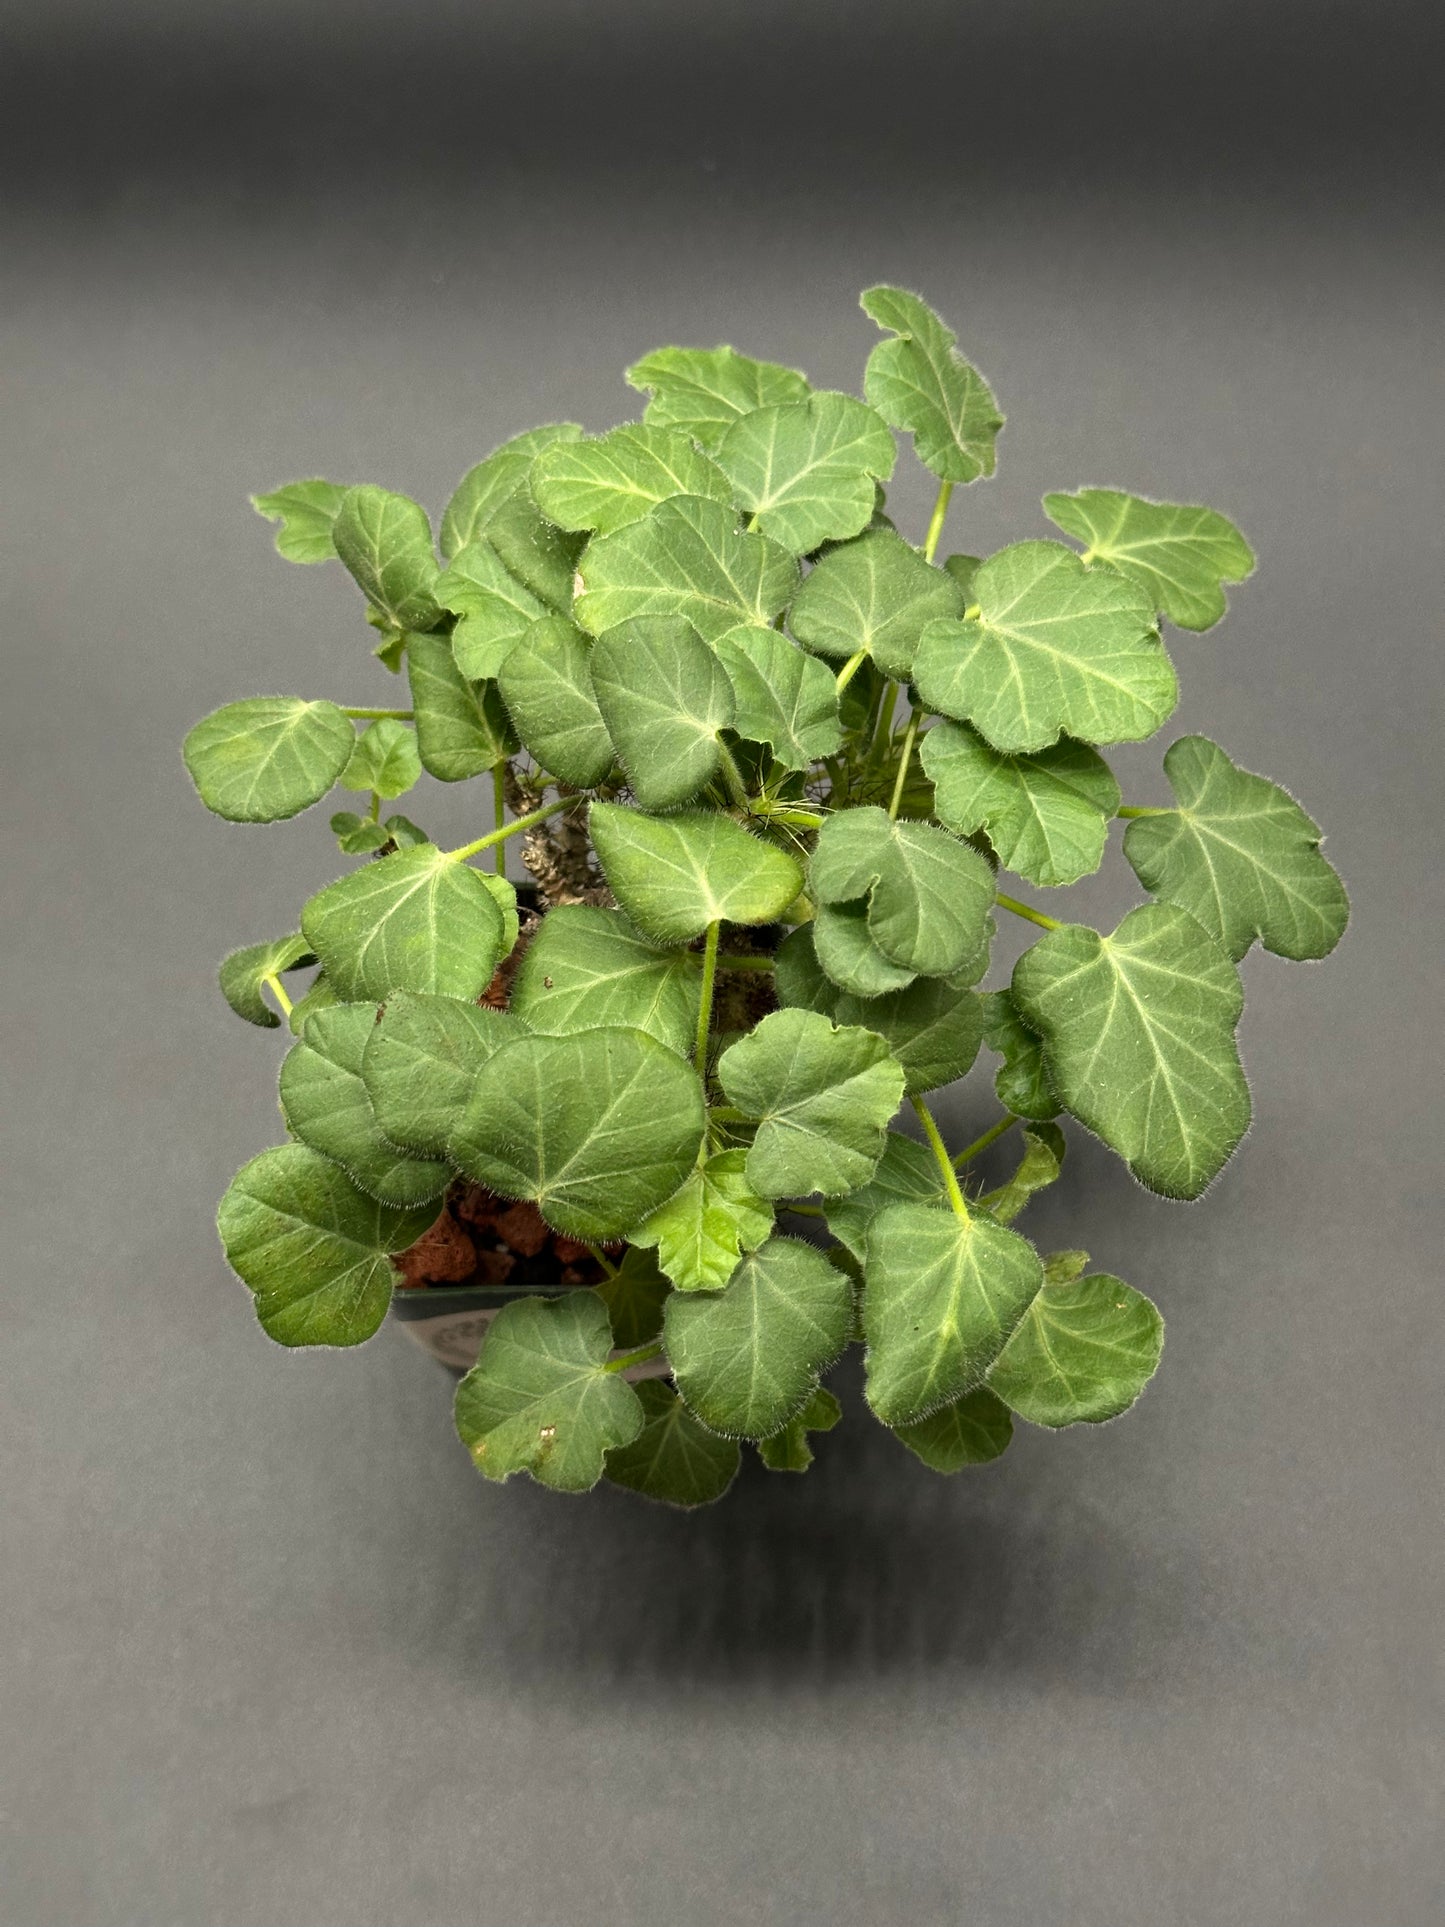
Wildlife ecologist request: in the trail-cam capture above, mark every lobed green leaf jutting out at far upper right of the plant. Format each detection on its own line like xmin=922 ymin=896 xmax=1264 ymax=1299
xmin=1044 ymin=488 xmax=1254 ymax=630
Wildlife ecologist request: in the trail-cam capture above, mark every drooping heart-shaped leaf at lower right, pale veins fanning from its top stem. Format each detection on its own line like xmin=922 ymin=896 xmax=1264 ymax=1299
xmin=863 ymin=1204 xmax=1044 ymax=1426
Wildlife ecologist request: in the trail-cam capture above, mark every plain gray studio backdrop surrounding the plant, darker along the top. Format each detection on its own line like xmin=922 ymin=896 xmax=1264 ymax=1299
xmin=0 ymin=0 xmax=1445 ymax=1927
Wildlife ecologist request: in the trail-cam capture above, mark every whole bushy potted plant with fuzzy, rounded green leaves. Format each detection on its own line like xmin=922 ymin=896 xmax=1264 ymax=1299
xmin=185 ymin=287 xmax=1349 ymax=1505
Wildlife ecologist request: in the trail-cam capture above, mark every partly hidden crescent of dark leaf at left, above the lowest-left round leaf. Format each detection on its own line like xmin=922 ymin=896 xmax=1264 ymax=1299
xmin=281 ymin=1004 xmax=451 ymax=1204
